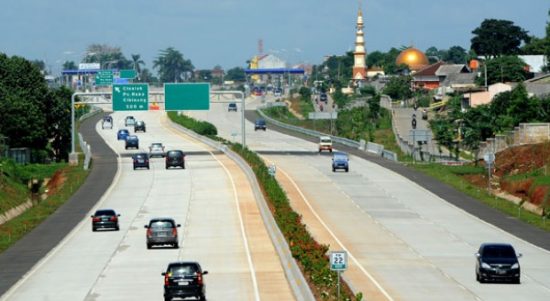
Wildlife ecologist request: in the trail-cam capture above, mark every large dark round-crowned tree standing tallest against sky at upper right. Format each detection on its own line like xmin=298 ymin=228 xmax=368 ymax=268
xmin=471 ymin=19 xmax=530 ymax=57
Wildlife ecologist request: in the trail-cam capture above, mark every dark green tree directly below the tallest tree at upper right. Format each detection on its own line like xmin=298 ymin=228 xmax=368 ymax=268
xmin=477 ymin=56 xmax=528 ymax=85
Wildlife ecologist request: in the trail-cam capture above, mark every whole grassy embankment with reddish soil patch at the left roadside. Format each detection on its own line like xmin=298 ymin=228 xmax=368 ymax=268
xmin=0 ymin=158 xmax=89 ymax=253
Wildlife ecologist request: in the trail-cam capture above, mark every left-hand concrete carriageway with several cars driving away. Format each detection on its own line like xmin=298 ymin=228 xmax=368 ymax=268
xmin=0 ymin=111 xmax=294 ymax=300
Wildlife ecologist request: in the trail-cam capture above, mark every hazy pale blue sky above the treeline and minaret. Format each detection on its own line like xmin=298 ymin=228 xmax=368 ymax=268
xmin=0 ymin=0 xmax=550 ymax=73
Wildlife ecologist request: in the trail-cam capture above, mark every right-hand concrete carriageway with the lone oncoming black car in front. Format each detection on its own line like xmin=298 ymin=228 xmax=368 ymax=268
xmin=189 ymin=94 xmax=550 ymax=300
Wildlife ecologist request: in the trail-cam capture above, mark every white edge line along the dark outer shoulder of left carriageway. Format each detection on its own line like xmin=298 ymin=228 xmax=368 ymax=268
xmin=0 ymin=122 xmax=122 ymax=300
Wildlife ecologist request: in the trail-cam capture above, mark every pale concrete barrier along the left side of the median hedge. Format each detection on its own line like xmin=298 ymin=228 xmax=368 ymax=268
xmin=171 ymin=122 xmax=315 ymax=301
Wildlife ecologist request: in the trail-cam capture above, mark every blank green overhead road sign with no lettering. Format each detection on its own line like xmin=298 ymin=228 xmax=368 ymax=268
xmin=164 ymin=83 xmax=210 ymax=111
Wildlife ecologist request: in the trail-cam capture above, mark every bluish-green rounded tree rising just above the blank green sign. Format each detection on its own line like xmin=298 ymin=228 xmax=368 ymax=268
xmin=153 ymin=47 xmax=194 ymax=82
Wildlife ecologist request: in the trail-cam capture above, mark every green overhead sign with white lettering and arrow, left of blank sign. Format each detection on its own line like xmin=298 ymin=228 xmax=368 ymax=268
xmin=113 ymin=84 xmax=149 ymax=111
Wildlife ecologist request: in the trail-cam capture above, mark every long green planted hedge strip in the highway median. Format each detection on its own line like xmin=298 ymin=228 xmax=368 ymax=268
xmin=168 ymin=112 xmax=362 ymax=301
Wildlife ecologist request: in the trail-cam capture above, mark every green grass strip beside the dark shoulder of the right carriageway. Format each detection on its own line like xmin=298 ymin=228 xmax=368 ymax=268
xmin=409 ymin=163 xmax=550 ymax=231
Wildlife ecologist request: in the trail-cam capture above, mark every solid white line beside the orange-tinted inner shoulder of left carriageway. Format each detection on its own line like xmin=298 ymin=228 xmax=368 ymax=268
xmin=162 ymin=115 xmax=261 ymax=301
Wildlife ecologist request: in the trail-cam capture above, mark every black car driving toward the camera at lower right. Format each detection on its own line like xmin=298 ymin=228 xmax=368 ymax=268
xmin=476 ymin=243 xmax=521 ymax=284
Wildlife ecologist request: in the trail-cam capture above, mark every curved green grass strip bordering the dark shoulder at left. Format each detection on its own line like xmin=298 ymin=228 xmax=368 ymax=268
xmin=0 ymin=157 xmax=89 ymax=253
